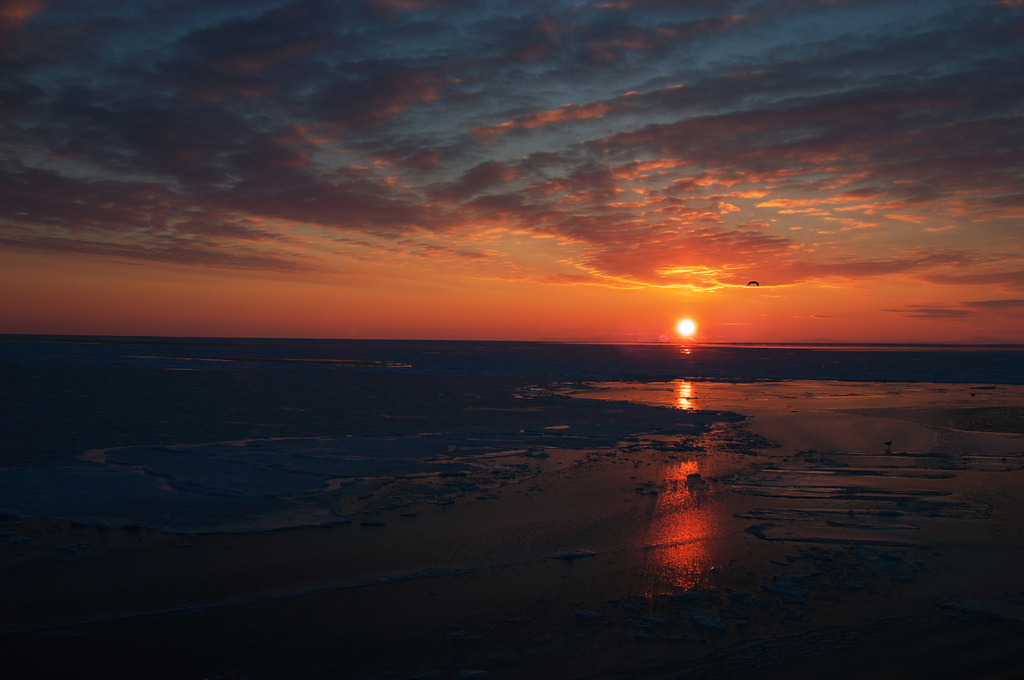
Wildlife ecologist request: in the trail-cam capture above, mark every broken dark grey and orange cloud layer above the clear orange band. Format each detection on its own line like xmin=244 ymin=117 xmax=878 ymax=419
xmin=0 ymin=0 xmax=1024 ymax=294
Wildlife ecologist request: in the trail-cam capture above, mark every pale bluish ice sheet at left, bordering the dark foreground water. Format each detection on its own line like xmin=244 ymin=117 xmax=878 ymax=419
xmin=0 ymin=433 xmax=557 ymax=533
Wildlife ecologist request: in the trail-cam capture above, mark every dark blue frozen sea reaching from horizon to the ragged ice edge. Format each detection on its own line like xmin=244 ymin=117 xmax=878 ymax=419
xmin=0 ymin=336 xmax=1024 ymax=532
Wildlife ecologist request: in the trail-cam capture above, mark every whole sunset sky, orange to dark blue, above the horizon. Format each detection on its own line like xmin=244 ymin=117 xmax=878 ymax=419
xmin=0 ymin=0 xmax=1024 ymax=342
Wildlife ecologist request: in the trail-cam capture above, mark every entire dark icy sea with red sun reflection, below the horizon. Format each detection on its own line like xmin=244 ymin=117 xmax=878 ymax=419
xmin=0 ymin=336 xmax=1024 ymax=680
